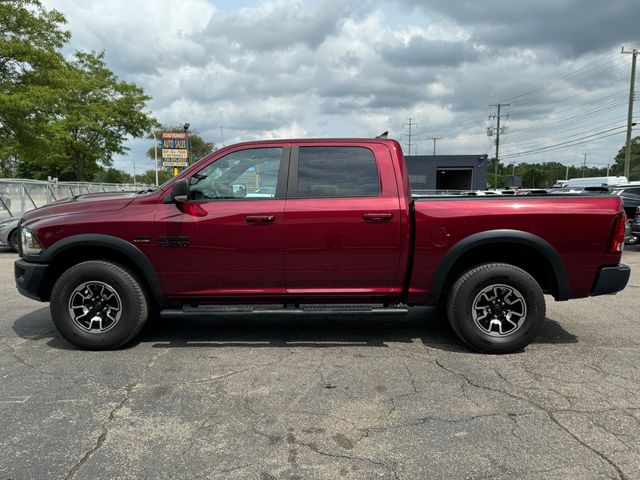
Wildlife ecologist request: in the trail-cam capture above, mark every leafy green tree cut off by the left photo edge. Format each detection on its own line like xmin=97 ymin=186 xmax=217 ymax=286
xmin=0 ymin=0 xmax=70 ymax=176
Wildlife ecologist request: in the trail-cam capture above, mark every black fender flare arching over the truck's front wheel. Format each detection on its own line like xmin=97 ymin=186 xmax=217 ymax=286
xmin=35 ymin=233 xmax=167 ymax=306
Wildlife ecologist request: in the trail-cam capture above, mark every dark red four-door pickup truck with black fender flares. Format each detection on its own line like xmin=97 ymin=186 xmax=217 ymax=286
xmin=15 ymin=139 xmax=630 ymax=353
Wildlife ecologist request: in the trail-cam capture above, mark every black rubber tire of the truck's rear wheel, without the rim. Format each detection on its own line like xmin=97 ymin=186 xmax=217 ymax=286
xmin=454 ymin=265 xmax=545 ymax=353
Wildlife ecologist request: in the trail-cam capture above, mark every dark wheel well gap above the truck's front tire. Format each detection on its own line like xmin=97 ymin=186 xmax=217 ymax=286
xmin=38 ymin=245 xmax=157 ymax=302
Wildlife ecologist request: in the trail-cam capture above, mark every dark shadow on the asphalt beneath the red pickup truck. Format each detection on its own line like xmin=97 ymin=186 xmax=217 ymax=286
xmin=13 ymin=308 xmax=578 ymax=353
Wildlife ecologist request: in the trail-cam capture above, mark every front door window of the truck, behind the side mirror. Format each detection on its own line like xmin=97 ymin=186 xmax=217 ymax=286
xmin=189 ymin=147 xmax=282 ymax=201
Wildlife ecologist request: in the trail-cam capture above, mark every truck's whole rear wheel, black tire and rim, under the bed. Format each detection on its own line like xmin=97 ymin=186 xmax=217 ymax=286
xmin=447 ymin=263 xmax=545 ymax=353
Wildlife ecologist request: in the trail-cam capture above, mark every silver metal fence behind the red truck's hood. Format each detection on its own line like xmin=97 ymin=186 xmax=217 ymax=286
xmin=0 ymin=178 xmax=148 ymax=221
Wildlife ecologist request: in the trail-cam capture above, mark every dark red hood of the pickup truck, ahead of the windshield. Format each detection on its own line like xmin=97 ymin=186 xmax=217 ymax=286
xmin=23 ymin=192 xmax=138 ymax=222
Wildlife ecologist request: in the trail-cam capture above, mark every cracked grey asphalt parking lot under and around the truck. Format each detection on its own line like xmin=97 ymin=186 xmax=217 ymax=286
xmin=0 ymin=247 xmax=640 ymax=480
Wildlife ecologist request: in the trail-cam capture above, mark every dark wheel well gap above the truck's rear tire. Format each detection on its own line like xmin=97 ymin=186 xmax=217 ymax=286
xmin=440 ymin=242 xmax=558 ymax=298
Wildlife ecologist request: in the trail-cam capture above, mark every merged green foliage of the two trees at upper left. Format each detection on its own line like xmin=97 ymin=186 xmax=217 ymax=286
xmin=0 ymin=0 xmax=156 ymax=180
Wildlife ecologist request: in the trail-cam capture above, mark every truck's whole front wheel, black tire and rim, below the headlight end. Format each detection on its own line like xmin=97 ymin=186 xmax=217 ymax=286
xmin=50 ymin=261 xmax=149 ymax=350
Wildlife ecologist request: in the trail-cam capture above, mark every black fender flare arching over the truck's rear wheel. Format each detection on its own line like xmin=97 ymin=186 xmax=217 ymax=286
xmin=429 ymin=229 xmax=569 ymax=301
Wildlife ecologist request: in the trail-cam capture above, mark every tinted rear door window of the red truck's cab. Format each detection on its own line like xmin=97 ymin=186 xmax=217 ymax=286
xmin=297 ymin=147 xmax=380 ymax=198
